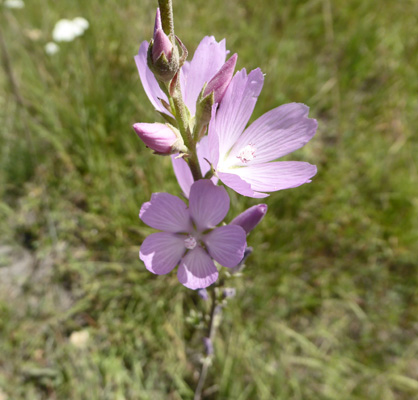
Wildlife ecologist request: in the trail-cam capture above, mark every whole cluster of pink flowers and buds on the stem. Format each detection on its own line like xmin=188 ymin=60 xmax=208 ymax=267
xmin=134 ymin=6 xmax=317 ymax=289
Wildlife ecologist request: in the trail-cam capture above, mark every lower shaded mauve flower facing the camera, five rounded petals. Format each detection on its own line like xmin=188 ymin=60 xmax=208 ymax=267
xmin=139 ymin=179 xmax=246 ymax=289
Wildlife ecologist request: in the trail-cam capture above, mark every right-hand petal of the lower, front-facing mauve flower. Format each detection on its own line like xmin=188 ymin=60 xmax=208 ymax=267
xmin=203 ymin=225 xmax=247 ymax=268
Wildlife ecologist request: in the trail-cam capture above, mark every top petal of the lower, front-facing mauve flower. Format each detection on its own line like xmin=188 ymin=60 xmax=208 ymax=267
xmin=189 ymin=179 xmax=229 ymax=231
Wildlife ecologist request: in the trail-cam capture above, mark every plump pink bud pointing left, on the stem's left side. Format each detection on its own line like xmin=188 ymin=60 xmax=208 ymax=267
xmin=133 ymin=123 xmax=187 ymax=155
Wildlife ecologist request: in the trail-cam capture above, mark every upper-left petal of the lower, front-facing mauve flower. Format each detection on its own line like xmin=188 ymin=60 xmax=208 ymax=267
xmin=139 ymin=193 xmax=191 ymax=233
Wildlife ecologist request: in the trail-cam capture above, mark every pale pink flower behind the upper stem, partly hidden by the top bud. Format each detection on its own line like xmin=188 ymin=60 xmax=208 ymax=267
xmin=135 ymin=36 xmax=229 ymax=115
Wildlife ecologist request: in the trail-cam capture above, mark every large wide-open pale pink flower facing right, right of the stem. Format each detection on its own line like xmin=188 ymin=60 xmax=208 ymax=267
xmin=209 ymin=69 xmax=317 ymax=198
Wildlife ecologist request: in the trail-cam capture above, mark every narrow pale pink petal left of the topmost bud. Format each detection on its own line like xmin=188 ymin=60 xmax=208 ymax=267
xmin=135 ymin=41 xmax=171 ymax=115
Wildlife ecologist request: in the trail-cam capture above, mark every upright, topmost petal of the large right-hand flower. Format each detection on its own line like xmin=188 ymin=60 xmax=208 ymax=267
xmin=209 ymin=68 xmax=264 ymax=162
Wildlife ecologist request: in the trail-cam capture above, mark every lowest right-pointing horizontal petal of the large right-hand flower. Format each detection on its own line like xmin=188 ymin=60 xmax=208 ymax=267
xmin=232 ymin=161 xmax=316 ymax=197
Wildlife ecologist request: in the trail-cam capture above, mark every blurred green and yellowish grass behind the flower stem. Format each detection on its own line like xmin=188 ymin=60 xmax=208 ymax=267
xmin=0 ymin=0 xmax=418 ymax=400
